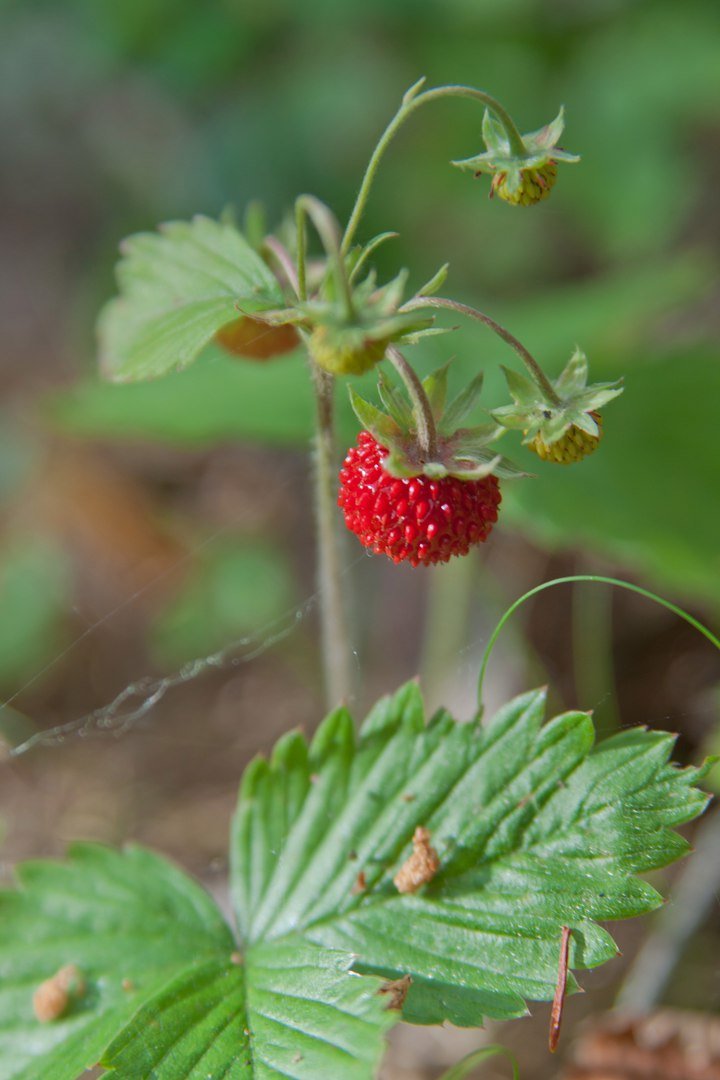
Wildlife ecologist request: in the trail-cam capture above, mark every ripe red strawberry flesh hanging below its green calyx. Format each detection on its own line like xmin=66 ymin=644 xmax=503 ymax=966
xmin=338 ymin=431 xmax=500 ymax=566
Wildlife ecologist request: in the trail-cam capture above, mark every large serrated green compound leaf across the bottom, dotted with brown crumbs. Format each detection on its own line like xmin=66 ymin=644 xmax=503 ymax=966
xmin=0 ymin=684 xmax=707 ymax=1080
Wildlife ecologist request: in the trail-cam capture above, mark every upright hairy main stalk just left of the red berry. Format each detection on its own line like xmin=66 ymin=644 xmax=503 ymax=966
xmin=311 ymin=361 xmax=352 ymax=708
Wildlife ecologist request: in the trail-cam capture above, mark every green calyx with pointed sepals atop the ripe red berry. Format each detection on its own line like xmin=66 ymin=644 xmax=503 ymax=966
xmin=350 ymin=364 xmax=526 ymax=481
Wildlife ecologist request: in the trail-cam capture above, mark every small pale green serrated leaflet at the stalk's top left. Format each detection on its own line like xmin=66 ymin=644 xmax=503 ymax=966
xmin=97 ymin=216 xmax=283 ymax=382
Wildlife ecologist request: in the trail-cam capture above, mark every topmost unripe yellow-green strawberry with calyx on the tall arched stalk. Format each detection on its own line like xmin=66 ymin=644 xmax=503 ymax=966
xmin=452 ymin=109 xmax=580 ymax=205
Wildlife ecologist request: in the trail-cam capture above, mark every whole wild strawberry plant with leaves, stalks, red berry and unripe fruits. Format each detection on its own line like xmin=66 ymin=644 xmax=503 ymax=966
xmin=0 ymin=81 xmax=706 ymax=1080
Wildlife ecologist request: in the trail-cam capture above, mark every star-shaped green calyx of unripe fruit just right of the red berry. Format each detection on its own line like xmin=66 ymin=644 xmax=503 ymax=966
xmin=491 ymin=349 xmax=623 ymax=446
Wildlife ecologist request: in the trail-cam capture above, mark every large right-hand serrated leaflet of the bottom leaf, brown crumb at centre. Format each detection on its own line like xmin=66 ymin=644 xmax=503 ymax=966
xmin=231 ymin=685 xmax=706 ymax=1025
